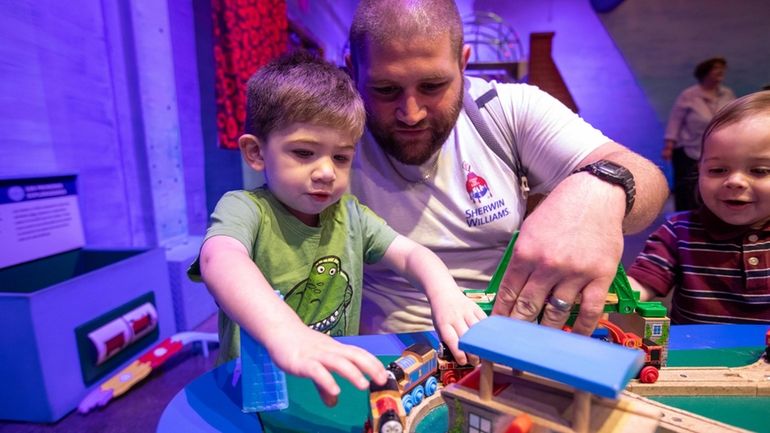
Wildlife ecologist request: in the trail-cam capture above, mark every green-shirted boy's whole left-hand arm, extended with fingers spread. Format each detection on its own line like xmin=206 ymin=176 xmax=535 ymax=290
xmin=200 ymin=236 xmax=387 ymax=406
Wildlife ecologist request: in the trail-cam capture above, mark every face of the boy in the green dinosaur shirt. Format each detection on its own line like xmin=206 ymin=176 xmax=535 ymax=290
xmin=262 ymin=123 xmax=355 ymax=226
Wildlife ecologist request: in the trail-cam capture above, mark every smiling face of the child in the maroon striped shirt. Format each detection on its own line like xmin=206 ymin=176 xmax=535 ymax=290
xmin=698 ymin=115 xmax=770 ymax=228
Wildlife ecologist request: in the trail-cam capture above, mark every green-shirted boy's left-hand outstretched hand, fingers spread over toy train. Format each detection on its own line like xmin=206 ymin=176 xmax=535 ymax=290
xmin=265 ymin=326 xmax=388 ymax=407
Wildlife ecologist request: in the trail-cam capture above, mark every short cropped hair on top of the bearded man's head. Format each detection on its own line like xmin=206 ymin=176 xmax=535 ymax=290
xmin=349 ymin=0 xmax=463 ymax=67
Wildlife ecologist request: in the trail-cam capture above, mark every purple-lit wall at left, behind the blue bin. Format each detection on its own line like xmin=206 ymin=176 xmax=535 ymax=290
xmin=0 ymin=0 xmax=213 ymax=246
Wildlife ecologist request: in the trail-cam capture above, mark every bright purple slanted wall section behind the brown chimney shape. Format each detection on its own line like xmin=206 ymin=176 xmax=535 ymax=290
xmin=475 ymin=0 xmax=663 ymax=177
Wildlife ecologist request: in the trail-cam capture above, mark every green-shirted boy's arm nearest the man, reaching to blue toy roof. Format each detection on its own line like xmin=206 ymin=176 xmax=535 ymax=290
xmin=382 ymin=235 xmax=486 ymax=364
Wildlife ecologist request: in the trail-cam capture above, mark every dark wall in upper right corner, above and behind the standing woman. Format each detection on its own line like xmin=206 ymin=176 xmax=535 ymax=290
xmin=598 ymin=0 xmax=770 ymax=121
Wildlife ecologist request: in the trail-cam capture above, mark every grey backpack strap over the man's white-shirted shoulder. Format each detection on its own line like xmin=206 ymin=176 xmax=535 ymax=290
xmin=463 ymin=80 xmax=529 ymax=199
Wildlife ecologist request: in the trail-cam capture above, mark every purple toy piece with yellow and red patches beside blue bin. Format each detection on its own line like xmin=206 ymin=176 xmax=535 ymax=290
xmin=78 ymin=332 xmax=214 ymax=414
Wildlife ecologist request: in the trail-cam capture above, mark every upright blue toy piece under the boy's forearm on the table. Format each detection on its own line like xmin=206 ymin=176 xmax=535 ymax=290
xmin=241 ymin=329 xmax=289 ymax=413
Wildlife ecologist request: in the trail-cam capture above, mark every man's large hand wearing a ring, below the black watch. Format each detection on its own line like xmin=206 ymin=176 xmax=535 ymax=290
xmin=492 ymin=173 xmax=625 ymax=334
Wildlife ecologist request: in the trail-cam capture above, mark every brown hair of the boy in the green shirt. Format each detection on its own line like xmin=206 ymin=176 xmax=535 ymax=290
xmin=245 ymin=51 xmax=366 ymax=141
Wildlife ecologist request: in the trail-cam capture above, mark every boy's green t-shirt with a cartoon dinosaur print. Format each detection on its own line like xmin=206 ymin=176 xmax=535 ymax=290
xmin=188 ymin=187 xmax=397 ymax=362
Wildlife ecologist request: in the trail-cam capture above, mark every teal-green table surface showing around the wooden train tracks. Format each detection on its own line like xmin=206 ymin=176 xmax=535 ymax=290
xmin=261 ymin=347 xmax=770 ymax=433
